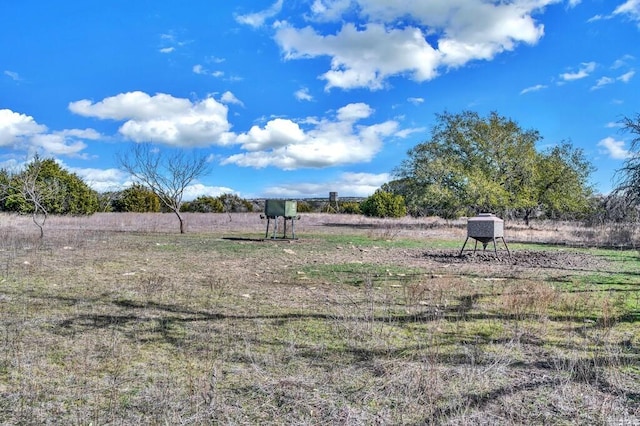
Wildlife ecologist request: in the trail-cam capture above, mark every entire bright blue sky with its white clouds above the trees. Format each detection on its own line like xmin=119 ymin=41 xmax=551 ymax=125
xmin=0 ymin=0 xmax=640 ymax=199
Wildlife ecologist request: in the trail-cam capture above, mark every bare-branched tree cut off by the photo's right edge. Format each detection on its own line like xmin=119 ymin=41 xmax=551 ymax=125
xmin=614 ymin=113 xmax=640 ymax=205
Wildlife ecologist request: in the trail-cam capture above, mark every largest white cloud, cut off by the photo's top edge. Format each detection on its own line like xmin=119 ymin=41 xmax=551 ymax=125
xmin=275 ymin=0 xmax=558 ymax=90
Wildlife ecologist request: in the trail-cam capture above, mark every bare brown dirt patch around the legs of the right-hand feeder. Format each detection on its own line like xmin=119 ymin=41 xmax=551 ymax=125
xmin=423 ymin=250 xmax=607 ymax=270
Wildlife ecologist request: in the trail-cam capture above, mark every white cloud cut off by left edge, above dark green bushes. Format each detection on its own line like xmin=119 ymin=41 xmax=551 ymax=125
xmin=0 ymin=109 xmax=92 ymax=156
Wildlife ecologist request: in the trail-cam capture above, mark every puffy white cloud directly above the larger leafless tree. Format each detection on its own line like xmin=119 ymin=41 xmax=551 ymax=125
xmin=69 ymin=92 xmax=231 ymax=147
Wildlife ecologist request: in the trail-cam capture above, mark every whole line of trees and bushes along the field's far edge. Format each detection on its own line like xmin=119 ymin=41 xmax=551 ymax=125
xmin=0 ymin=111 xmax=640 ymax=234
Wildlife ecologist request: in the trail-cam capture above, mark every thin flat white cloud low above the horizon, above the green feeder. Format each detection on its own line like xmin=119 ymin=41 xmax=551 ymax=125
xmin=264 ymin=172 xmax=391 ymax=199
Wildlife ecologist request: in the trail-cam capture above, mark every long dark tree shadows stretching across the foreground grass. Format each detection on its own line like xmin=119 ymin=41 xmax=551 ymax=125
xmin=45 ymin=294 xmax=640 ymax=424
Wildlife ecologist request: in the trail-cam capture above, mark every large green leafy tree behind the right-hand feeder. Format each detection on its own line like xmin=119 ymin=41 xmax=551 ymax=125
xmin=390 ymin=111 xmax=591 ymax=221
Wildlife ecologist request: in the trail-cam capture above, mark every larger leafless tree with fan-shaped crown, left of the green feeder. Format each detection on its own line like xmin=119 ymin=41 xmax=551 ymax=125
xmin=118 ymin=144 xmax=208 ymax=234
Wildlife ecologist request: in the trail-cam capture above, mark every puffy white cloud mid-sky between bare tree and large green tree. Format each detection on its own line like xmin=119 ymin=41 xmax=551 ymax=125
xmin=222 ymin=103 xmax=398 ymax=170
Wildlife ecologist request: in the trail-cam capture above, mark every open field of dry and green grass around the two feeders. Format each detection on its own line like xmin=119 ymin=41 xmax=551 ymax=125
xmin=0 ymin=213 xmax=640 ymax=425
